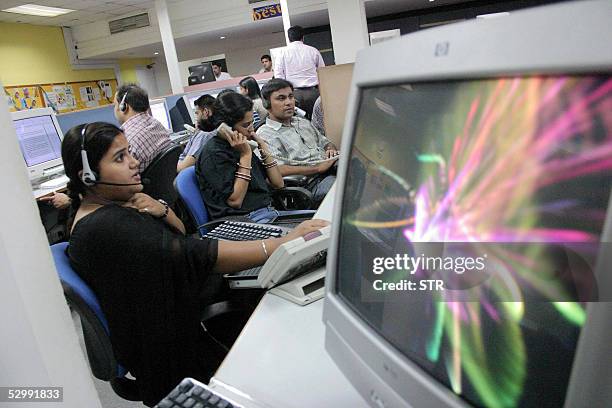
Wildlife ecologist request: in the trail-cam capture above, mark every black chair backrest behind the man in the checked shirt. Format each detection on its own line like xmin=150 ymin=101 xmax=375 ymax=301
xmin=142 ymin=143 xmax=183 ymax=206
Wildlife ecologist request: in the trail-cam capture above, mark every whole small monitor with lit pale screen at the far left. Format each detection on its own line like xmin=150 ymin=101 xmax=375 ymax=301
xmin=11 ymin=108 xmax=63 ymax=181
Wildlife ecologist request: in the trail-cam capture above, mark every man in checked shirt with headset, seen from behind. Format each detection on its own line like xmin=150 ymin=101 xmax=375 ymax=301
xmin=115 ymin=84 xmax=170 ymax=173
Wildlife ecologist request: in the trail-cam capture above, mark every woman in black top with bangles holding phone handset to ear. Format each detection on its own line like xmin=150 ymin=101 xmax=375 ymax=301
xmin=195 ymin=92 xmax=284 ymax=222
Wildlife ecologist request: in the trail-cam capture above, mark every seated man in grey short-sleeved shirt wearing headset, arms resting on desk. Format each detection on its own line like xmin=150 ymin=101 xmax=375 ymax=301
xmin=257 ymin=79 xmax=338 ymax=204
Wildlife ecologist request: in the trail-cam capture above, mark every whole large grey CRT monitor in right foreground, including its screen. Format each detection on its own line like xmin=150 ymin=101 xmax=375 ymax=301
xmin=324 ymin=1 xmax=612 ymax=407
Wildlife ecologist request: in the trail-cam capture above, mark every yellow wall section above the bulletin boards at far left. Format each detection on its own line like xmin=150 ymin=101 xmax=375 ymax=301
xmin=0 ymin=23 xmax=115 ymax=86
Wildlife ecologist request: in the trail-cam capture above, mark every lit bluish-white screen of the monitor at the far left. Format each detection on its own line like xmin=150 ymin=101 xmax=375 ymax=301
xmin=13 ymin=115 xmax=62 ymax=167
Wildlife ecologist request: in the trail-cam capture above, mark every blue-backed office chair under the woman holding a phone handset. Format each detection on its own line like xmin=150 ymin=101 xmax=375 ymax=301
xmin=174 ymin=166 xmax=315 ymax=237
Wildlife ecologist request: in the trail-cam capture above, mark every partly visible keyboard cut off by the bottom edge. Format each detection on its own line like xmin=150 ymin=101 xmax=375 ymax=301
xmin=155 ymin=378 xmax=243 ymax=408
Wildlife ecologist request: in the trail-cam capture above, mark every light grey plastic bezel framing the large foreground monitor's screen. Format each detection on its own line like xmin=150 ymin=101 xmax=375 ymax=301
xmin=323 ymin=1 xmax=612 ymax=407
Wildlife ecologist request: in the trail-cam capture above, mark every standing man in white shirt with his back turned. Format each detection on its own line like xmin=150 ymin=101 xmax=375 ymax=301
xmin=274 ymin=26 xmax=325 ymax=119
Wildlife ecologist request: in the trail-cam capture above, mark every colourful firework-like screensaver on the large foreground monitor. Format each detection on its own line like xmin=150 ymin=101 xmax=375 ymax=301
xmin=337 ymin=75 xmax=612 ymax=407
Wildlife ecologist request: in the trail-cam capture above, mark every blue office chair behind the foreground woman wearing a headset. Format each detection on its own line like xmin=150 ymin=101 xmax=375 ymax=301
xmin=51 ymin=242 xmax=142 ymax=401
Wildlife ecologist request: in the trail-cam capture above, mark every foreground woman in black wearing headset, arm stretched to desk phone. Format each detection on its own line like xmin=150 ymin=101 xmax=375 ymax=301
xmin=62 ymin=123 xmax=324 ymax=405
